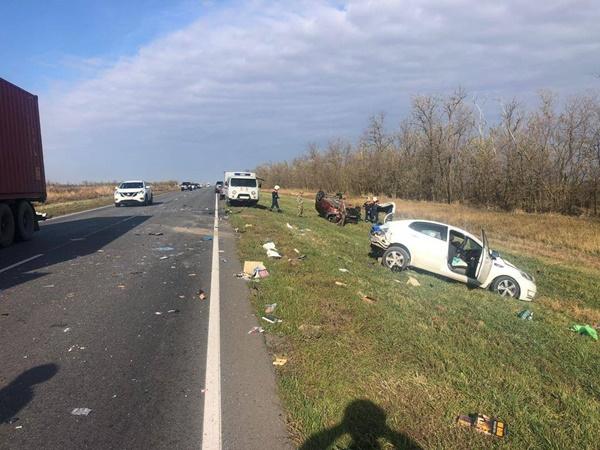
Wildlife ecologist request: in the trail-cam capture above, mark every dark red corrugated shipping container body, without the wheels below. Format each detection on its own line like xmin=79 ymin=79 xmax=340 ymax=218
xmin=0 ymin=78 xmax=46 ymax=201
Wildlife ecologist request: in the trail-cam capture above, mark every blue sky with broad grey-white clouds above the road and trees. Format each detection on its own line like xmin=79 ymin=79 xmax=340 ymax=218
xmin=0 ymin=0 xmax=600 ymax=182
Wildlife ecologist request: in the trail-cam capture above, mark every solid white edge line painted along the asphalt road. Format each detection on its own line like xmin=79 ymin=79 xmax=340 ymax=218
xmin=202 ymin=195 xmax=222 ymax=450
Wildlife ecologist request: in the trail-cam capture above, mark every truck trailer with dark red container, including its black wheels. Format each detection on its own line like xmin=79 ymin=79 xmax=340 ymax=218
xmin=0 ymin=78 xmax=46 ymax=248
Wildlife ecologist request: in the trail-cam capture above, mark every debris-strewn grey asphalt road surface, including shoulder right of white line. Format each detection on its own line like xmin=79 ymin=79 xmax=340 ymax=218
xmin=0 ymin=189 xmax=289 ymax=449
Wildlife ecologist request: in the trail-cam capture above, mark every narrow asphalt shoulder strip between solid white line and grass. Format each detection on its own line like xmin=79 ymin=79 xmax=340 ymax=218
xmin=220 ymin=209 xmax=293 ymax=450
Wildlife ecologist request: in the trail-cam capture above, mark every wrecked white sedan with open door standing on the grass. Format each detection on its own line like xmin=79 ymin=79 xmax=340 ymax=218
xmin=371 ymin=220 xmax=537 ymax=301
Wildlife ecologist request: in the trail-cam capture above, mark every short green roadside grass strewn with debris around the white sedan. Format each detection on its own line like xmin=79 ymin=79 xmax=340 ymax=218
xmin=230 ymin=197 xmax=600 ymax=449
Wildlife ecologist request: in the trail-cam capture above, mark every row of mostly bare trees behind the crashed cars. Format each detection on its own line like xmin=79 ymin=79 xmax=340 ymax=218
xmin=256 ymin=89 xmax=600 ymax=215
